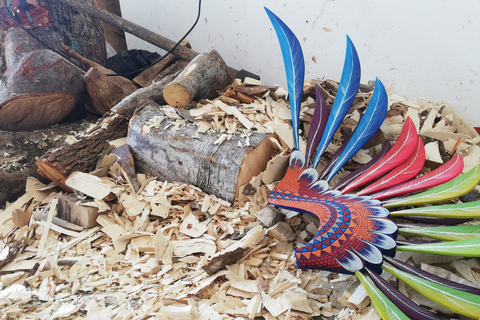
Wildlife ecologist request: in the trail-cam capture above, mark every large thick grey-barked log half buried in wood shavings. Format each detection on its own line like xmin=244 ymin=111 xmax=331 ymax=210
xmin=127 ymin=101 xmax=276 ymax=202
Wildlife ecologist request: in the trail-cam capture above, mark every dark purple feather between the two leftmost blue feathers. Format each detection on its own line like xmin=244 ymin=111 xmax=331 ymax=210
xmin=305 ymin=84 xmax=328 ymax=167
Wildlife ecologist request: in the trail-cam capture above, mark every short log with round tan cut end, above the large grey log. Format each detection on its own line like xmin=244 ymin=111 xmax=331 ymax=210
xmin=163 ymin=49 xmax=232 ymax=108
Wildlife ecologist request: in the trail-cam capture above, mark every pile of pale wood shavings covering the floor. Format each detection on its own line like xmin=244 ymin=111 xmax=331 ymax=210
xmin=0 ymin=78 xmax=479 ymax=319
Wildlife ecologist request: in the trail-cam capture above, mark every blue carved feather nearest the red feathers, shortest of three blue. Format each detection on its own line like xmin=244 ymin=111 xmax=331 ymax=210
xmin=326 ymin=78 xmax=388 ymax=181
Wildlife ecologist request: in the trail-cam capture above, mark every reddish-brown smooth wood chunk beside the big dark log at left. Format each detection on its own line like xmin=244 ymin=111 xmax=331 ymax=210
xmin=84 ymin=68 xmax=138 ymax=115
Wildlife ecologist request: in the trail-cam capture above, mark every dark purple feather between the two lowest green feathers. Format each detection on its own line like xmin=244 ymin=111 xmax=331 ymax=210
xmin=365 ymin=268 xmax=440 ymax=320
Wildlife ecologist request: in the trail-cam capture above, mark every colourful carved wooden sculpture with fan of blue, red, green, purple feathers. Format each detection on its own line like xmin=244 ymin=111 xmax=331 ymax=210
xmin=266 ymin=9 xmax=480 ymax=320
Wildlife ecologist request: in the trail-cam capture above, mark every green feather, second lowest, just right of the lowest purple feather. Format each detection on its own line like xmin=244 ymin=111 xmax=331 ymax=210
xmin=382 ymin=264 xmax=480 ymax=319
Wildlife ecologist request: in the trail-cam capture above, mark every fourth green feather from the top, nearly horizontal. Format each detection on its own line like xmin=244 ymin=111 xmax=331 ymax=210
xmin=397 ymin=238 xmax=480 ymax=258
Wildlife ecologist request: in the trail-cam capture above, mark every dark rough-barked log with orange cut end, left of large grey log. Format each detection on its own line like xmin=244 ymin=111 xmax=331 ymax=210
xmin=36 ymin=113 xmax=128 ymax=192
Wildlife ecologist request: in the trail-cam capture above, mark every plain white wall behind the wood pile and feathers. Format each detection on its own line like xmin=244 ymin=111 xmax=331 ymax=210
xmin=120 ymin=0 xmax=480 ymax=126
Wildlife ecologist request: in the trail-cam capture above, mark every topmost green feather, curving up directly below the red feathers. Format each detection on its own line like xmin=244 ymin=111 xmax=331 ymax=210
xmin=384 ymin=165 xmax=480 ymax=208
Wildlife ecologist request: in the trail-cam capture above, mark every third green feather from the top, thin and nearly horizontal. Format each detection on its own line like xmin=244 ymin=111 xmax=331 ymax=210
xmin=398 ymin=225 xmax=480 ymax=241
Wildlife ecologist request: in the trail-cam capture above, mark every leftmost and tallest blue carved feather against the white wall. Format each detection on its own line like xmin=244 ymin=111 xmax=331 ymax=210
xmin=265 ymin=8 xmax=305 ymax=149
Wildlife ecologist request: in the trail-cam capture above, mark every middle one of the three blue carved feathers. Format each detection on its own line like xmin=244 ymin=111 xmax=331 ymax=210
xmin=312 ymin=36 xmax=360 ymax=168
